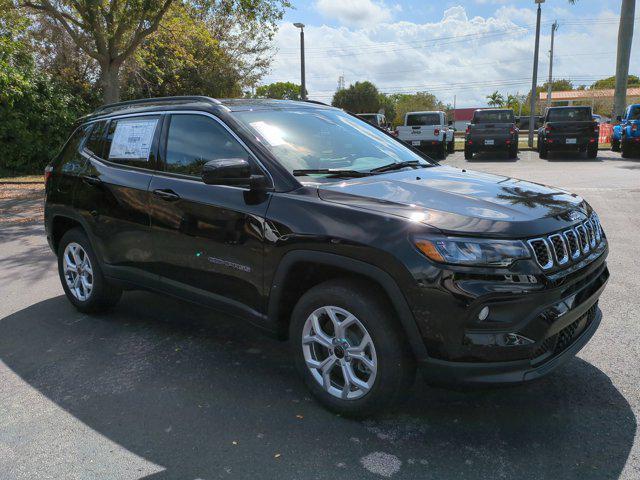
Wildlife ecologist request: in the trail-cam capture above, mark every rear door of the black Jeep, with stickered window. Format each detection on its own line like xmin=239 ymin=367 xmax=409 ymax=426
xmin=76 ymin=114 xmax=162 ymax=283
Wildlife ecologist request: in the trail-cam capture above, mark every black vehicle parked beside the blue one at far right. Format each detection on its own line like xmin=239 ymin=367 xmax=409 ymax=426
xmin=538 ymin=106 xmax=600 ymax=158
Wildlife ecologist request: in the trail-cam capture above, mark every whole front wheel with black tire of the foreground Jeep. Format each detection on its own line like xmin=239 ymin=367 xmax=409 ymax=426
xmin=289 ymin=280 xmax=415 ymax=417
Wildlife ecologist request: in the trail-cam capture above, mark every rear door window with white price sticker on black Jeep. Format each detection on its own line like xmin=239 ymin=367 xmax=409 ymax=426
xmin=105 ymin=116 xmax=160 ymax=168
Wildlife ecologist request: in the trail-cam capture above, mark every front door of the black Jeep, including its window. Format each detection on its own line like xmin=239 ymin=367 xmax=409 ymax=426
xmin=149 ymin=113 xmax=270 ymax=317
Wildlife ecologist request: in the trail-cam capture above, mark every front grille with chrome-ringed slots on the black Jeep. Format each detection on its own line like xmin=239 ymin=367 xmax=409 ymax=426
xmin=527 ymin=213 xmax=604 ymax=270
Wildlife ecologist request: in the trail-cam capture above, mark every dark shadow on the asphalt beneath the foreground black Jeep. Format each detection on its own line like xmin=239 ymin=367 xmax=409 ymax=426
xmin=0 ymin=292 xmax=636 ymax=480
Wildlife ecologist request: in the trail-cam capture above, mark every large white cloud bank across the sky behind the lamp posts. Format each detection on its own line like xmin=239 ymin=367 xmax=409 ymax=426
xmin=264 ymin=6 xmax=640 ymax=107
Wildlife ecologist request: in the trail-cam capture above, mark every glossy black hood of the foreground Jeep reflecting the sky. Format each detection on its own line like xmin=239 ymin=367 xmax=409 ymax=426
xmin=318 ymin=166 xmax=589 ymax=238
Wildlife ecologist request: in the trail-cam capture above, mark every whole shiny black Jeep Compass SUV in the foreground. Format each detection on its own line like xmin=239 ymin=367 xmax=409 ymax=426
xmin=45 ymin=97 xmax=609 ymax=415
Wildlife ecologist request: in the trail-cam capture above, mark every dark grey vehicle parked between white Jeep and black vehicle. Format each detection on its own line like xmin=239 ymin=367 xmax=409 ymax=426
xmin=464 ymin=109 xmax=518 ymax=160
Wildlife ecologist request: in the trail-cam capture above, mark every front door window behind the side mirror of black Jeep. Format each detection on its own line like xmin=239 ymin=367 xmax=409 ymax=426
xmin=165 ymin=114 xmax=249 ymax=176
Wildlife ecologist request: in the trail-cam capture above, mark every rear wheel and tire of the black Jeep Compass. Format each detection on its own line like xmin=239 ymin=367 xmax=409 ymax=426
xmin=58 ymin=228 xmax=122 ymax=313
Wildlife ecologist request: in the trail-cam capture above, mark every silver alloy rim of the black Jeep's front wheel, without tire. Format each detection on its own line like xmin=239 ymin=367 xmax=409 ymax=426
xmin=302 ymin=306 xmax=378 ymax=400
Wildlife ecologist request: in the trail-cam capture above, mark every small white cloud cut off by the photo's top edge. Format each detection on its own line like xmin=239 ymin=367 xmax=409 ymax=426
xmin=315 ymin=0 xmax=401 ymax=27
